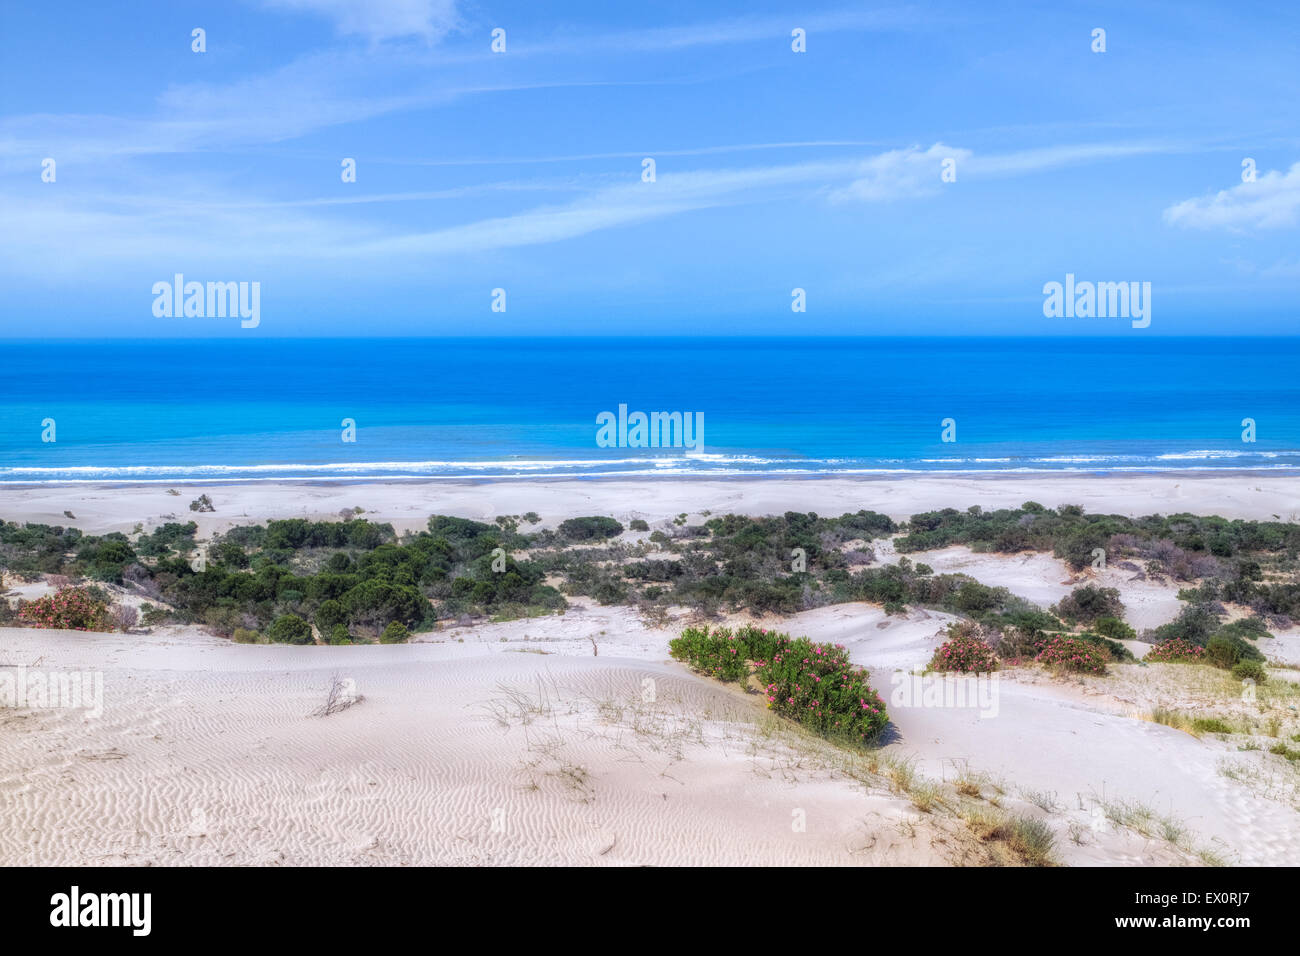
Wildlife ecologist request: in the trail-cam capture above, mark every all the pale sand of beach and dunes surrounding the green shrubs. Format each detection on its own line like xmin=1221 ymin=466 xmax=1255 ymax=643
xmin=0 ymin=473 xmax=1300 ymax=866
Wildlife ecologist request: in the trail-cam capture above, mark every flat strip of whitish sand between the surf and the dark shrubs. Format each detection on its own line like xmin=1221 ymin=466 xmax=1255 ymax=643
xmin=0 ymin=475 xmax=1300 ymax=535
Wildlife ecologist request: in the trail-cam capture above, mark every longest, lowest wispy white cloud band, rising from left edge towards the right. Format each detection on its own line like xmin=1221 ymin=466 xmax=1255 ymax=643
xmin=0 ymin=136 xmax=1180 ymax=274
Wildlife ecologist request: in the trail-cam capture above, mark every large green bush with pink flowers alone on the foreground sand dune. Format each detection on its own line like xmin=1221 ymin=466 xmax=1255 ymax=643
xmin=670 ymin=627 xmax=889 ymax=744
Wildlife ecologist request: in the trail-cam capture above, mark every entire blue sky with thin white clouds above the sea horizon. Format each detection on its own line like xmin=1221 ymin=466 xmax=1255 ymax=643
xmin=0 ymin=0 xmax=1300 ymax=337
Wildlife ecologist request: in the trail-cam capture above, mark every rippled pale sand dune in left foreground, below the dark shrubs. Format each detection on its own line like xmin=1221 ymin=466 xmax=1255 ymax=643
xmin=0 ymin=631 xmax=979 ymax=865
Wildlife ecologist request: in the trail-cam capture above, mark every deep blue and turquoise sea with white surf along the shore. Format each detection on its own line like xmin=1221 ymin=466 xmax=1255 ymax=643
xmin=0 ymin=334 xmax=1300 ymax=483
